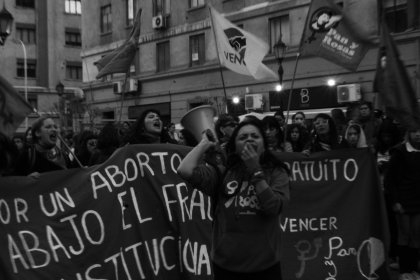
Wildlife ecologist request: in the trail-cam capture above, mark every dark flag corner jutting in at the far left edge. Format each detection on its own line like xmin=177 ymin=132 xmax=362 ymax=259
xmin=0 ymin=76 xmax=33 ymax=136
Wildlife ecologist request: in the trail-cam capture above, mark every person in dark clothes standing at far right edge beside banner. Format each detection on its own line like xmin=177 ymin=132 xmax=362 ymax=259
xmin=384 ymin=128 xmax=420 ymax=279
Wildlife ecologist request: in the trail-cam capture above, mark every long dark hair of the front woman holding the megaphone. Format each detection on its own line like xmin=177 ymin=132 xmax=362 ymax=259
xmin=226 ymin=119 xmax=288 ymax=171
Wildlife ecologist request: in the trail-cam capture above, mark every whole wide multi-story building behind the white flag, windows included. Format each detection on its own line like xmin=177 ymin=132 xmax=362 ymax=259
xmin=82 ymin=0 xmax=420 ymax=127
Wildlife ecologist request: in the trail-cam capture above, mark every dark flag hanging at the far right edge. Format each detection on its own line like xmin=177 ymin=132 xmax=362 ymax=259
xmin=374 ymin=20 xmax=420 ymax=129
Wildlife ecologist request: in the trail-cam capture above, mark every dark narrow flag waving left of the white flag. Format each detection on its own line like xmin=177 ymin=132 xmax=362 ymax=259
xmin=95 ymin=9 xmax=142 ymax=79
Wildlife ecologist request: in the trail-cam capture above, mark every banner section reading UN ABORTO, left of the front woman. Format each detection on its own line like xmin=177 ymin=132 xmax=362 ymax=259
xmin=0 ymin=145 xmax=212 ymax=280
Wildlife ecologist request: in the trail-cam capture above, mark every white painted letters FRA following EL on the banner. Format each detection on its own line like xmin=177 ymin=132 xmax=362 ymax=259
xmin=162 ymin=182 xmax=213 ymax=222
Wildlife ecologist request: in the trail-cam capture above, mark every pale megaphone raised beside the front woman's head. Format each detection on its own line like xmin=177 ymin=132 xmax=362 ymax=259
xmin=181 ymin=105 xmax=217 ymax=142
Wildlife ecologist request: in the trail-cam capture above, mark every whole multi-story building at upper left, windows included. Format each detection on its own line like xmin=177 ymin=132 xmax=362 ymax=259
xmin=0 ymin=0 xmax=83 ymax=133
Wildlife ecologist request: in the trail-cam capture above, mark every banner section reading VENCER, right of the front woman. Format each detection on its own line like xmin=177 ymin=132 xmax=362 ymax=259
xmin=280 ymin=149 xmax=389 ymax=280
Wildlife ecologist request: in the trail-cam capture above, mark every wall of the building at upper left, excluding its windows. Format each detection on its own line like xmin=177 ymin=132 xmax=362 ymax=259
xmin=0 ymin=0 xmax=82 ymax=133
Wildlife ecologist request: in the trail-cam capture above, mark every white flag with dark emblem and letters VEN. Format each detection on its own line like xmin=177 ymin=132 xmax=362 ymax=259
xmin=210 ymin=7 xmax=277 ymax=80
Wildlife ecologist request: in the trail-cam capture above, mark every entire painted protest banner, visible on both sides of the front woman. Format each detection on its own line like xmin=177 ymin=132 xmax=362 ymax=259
xmin=0 ymin=144 xmax=389 ymax=280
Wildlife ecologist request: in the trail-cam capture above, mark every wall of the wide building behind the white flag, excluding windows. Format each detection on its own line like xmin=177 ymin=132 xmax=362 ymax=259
xmin=82 ymin=0 xmax=420 ymax=127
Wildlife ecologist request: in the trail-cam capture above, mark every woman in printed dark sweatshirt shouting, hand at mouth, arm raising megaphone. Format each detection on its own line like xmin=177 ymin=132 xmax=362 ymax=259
xmin=178 ymin=119 xmax=289 ymax=280
